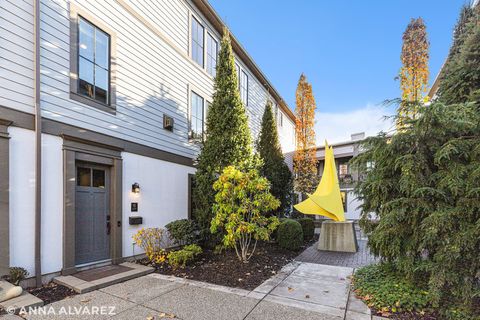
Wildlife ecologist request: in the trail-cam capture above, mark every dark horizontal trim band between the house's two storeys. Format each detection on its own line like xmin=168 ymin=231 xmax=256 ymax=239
xmin=0 ymin=105 xmax=194 ymax=167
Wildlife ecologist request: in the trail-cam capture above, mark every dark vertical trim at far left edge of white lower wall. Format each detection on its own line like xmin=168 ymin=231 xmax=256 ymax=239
xmin=0 ymin=119 xmax=11 ymax=276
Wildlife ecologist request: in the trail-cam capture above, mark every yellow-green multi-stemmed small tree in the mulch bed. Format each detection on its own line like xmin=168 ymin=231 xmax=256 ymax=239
xmin=210 ymin=166 xmax=280 ymax=263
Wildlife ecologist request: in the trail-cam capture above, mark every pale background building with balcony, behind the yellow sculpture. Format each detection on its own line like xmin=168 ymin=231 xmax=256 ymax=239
xmin=285 ymin=132 xmax=365 ymax=220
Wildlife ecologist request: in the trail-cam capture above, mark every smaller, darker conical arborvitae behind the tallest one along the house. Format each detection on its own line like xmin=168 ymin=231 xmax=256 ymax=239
xmin=257 ymin=101 xmax=293 ymax=213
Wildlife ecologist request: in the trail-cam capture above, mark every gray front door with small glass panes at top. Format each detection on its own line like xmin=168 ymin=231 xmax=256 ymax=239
xmin=75 ymin=163 xmax=111 ymax=265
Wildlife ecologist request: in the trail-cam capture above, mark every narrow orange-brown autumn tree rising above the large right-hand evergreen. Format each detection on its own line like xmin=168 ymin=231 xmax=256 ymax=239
xmin=397 ymin=18 xmax=430 ymax=127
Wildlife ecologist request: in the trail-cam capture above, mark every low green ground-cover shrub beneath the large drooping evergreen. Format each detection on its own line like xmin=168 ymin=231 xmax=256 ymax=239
xmin=353 ymin=264 xmax=431 ymax=316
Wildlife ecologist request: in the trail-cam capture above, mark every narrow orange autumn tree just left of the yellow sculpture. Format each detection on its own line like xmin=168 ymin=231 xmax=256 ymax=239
xmin=293 ymin=74 xmax=317 ymax=193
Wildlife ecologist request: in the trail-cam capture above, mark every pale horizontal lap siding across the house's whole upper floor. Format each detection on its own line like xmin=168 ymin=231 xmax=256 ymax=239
xmin=0 ymin=0 xmax=294 ymax=157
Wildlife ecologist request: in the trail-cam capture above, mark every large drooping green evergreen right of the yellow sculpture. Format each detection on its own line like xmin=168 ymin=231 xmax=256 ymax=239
xmin=353 ymin=102 xmax=480 ymax=319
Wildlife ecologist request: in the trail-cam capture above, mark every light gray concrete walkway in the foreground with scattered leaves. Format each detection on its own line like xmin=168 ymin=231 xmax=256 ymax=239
xmin=0 ymin=262 xmax=382 ymax=320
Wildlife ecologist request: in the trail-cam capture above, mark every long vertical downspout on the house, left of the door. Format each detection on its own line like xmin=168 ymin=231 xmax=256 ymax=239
xmin=33 ymin=0 xmax=42 ymax=287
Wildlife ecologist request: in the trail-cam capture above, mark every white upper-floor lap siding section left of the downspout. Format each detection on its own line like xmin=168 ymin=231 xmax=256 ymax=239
xmin=0 ymin=0 xmax=33 ymax=113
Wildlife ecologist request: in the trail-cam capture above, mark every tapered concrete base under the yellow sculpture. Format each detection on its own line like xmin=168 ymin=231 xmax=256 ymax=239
xmin=317 ymin=221 xmax=358 ymax=252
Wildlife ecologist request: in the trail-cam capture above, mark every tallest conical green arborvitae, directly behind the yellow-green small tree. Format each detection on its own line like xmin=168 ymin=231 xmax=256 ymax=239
xmin=193 ymin=30 xmax=252 ymax=235
